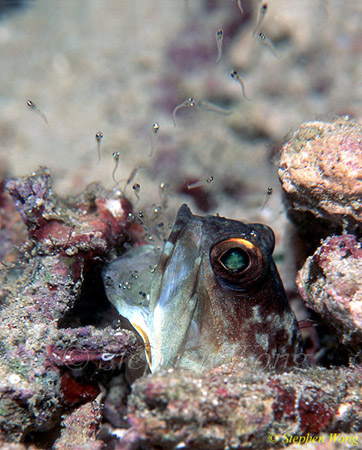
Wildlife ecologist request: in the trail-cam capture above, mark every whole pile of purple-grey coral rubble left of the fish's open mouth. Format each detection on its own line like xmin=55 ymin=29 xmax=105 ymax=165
xmin=0 ymin=169 xmax=136 ymax=441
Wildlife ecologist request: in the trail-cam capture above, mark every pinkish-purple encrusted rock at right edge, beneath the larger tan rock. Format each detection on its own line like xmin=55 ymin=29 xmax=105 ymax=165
xmin=297 ymin=235 xmax=362 ymax=351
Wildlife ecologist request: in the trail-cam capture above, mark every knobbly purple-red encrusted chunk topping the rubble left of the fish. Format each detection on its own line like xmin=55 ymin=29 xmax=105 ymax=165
xmin=6 ymin=169 xmax=132 ymax=257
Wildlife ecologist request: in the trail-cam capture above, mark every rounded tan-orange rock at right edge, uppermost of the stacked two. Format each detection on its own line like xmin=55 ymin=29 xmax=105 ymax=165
xmin=279 ymin=117 xmax=362 ymax=230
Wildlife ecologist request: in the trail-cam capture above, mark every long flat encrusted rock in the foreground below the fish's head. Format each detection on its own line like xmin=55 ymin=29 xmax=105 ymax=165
xmin=129 ymin=364 xmax=362 ymax=450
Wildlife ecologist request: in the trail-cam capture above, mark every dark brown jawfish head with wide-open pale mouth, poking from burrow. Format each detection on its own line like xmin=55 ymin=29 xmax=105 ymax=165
xmin=103 ymin=205 xmax=305 ymax=372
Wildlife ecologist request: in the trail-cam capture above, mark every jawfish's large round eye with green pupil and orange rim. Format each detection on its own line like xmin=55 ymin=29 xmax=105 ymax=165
xmin=209 ymin=238 xmax=268 ymax=291
